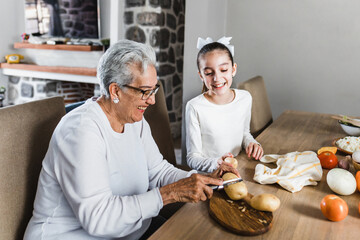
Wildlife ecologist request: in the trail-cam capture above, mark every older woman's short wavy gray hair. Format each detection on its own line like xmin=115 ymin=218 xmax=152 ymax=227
xmin=97 ymin=40 xmax=156 ymax=97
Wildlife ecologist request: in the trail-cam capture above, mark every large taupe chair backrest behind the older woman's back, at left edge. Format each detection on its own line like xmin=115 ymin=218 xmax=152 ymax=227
xmin=0 ymin=97 xmax=65 ymax=240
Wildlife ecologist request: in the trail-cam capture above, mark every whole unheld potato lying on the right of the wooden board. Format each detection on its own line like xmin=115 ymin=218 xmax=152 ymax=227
xmin=250 ymin=193 xmax=280 ymax=212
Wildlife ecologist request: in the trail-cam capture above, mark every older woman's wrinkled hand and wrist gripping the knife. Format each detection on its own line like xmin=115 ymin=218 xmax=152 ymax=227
xmin=160 ymin=173 xmax=223 ymax=205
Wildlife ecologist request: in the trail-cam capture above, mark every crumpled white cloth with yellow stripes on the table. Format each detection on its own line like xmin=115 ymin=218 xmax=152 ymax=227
xmin=254 ymin=151 xmax=322 ymax=192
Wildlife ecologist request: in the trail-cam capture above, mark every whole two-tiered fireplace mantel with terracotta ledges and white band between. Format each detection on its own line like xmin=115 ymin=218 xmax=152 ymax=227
xmin=0 ymin=42 xmax=103 ymax=84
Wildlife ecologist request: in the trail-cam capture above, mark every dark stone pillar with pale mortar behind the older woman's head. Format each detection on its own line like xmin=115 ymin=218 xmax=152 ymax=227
xmin=124 ymin=0 xmax=185 ymax=138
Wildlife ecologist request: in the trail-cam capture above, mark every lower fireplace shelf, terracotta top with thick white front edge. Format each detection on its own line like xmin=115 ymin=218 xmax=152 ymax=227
xmin=0 ymin=63 xmax=98 ymax=84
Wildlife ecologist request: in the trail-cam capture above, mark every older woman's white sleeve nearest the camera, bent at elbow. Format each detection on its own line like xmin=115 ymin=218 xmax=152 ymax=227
xmin=52 ymin=126 xmax=163 ymax=238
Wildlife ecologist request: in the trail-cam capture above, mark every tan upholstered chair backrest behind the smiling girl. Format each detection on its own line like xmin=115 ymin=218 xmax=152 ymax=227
xmin=238 ymin=76 xmax=273 ymax=137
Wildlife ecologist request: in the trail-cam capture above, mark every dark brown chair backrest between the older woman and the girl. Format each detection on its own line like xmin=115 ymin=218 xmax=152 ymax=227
xmin=144 ymin=82 xmax=176 ymax=166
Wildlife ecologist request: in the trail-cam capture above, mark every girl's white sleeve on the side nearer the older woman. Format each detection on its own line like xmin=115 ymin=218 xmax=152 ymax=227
xmin=185 ymin=103 xmax=218 ymax=172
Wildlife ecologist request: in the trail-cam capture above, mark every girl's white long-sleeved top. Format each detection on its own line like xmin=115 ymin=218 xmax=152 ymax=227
xmin=185 ymin=89 xmax=258 ymax=172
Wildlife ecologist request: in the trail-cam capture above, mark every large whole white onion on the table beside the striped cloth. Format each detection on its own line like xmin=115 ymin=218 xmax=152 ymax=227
xmin=326 ymin=168 xmax=356 ymax=195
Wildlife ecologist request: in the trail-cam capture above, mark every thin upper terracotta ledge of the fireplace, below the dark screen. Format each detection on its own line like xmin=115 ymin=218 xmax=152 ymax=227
xmin=14 ymin=42 xmax=103 ymax=52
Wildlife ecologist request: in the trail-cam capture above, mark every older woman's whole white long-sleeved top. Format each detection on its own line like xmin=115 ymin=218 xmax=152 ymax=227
xmin=24 ymin=99 xmax=192 ymax=240
